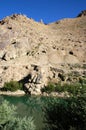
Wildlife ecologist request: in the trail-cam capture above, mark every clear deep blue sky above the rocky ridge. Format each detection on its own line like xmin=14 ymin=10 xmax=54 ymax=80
xmin=0 ymin=0 xmax=86 ymax=23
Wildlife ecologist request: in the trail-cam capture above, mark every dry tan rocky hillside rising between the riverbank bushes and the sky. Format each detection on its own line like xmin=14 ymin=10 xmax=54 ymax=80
xmin=0 ymin=11 xmax=86 ymax=94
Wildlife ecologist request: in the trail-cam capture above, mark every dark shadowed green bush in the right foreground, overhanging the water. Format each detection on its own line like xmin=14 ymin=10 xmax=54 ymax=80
xmin=44 ymin=97 xmax=86 ymax=130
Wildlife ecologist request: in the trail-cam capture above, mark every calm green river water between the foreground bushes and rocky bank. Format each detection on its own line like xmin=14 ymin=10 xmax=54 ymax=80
xmin=0 ymin=95 xmax=48 ymax=130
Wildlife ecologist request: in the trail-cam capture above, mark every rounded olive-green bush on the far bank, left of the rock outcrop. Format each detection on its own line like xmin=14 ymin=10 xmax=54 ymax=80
xmin=1 ymin=81 xmax=23 ymax=92
